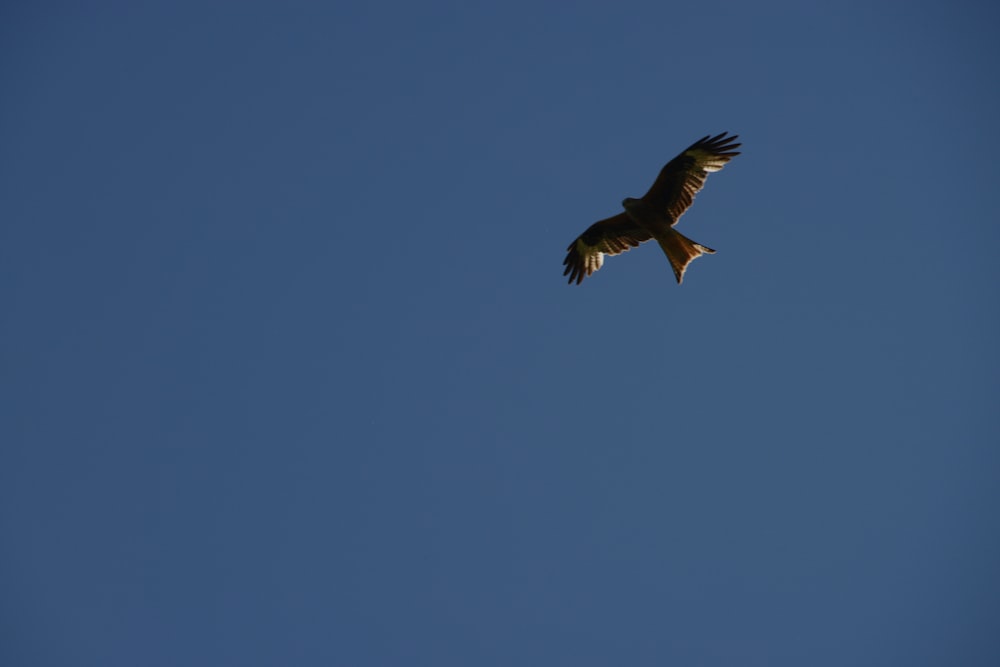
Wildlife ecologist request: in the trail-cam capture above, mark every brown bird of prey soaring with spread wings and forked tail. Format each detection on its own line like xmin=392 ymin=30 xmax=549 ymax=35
xmin=563 ymin=132 xmax=741 ymax=285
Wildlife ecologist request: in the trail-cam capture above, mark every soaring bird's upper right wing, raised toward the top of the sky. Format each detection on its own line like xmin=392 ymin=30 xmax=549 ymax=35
xmin=643 ymin=132 xmax=741 ymax=225
